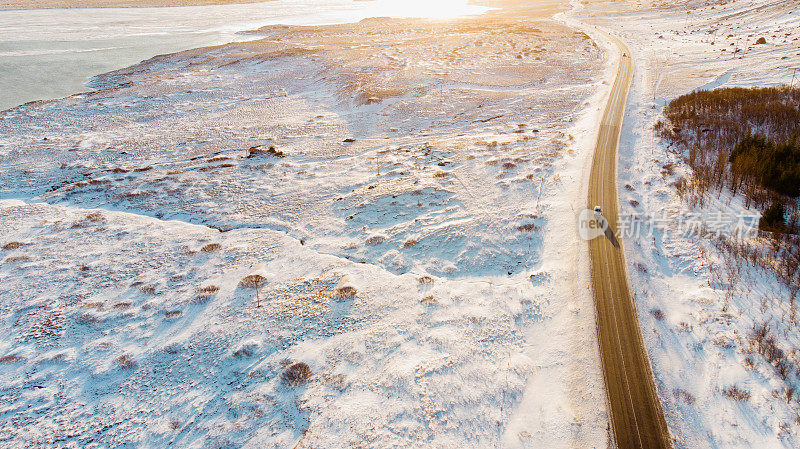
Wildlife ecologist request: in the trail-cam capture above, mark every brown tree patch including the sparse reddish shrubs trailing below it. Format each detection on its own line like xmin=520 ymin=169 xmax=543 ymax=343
xmin=656 ymin=86 xmax=800 ymax=296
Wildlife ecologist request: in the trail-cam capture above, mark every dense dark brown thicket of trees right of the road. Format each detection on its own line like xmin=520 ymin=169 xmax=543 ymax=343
xmin=656 ymin=87 xmax=800 ymax=210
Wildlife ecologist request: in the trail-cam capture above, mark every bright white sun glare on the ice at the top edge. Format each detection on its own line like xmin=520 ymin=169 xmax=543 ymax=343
xmin=360 ymin=0 xmax=490 ymax=19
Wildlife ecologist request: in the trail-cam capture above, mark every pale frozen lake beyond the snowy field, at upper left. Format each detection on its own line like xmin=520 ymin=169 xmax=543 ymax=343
xmin=0 ymin=0 xmax=488 ymax=110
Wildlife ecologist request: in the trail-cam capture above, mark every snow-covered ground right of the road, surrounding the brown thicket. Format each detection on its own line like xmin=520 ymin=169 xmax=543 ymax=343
xmin=578 ymin=0 xmax=800 ymax=448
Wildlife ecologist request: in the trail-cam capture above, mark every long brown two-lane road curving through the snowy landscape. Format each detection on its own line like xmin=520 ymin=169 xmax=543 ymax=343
xmin=587 ymin=36 xmax=671 ymax=449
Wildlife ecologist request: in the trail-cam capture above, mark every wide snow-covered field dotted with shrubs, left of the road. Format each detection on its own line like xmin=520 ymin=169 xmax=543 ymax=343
xmin=0 ymin=15 xmax=613 ymax=448
